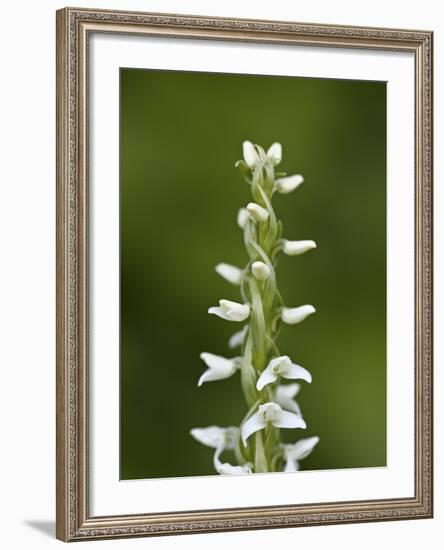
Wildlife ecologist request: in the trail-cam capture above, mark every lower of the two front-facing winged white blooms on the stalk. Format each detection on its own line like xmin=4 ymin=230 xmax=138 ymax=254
xmin=241 ymin=402 xmax=307 ymax=446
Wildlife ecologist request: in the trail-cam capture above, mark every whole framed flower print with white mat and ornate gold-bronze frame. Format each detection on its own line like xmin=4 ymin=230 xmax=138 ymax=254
xmin=57 ymin=8 xmax=432 ymax=541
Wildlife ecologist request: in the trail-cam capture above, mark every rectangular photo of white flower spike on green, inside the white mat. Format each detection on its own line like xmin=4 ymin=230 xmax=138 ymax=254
xmin=119 ymin=67 xmax=387 ymax=484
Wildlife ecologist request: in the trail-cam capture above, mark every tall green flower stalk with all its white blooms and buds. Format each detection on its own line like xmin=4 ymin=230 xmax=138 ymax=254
xmin=191 ymin=141 xmax=319 ymax=475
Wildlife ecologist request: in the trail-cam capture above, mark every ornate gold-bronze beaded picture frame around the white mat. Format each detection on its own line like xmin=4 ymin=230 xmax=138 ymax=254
xmin=56 ymin=8 xmax=433 ymax=541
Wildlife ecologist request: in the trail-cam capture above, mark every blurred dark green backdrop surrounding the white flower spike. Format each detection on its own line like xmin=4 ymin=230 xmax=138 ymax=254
xmin=120 ymin=69 xmax=386 ymax=479
